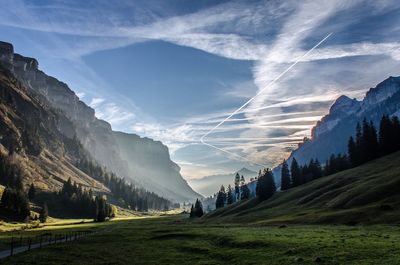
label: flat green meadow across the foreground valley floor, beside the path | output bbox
[2,215,400,265]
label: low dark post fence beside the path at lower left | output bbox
[0,230,94,259]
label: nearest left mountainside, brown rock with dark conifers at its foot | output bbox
[0,43,171,220]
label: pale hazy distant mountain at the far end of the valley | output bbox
[189,168,258,196]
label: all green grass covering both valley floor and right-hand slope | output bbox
[0,153,400,265]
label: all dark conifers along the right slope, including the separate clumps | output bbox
[206,115,400,208]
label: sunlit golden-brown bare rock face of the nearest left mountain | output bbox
[0,52,109,192]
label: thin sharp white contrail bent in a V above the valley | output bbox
[200,32,333,167]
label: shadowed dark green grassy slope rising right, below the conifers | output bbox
[203,152,400,224]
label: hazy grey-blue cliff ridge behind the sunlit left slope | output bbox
[0,42,201,201]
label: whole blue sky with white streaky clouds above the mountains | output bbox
[0,0,400,179]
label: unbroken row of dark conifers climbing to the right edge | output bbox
[281,115,400,190]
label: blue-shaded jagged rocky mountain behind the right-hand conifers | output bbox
[273,77,400,184]
